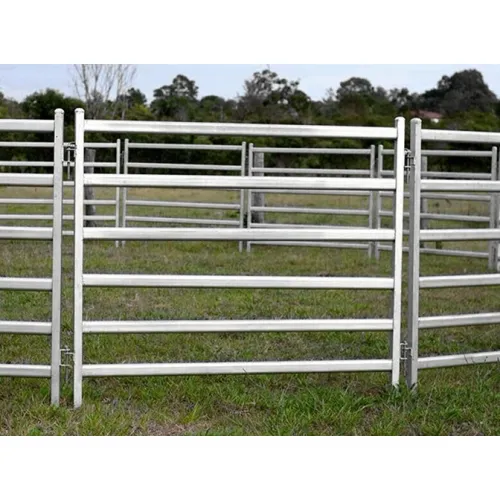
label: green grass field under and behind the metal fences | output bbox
[0,183,500,435]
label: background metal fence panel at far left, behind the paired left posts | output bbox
[0,139,121,238]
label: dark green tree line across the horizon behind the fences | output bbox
[0,65,500,174]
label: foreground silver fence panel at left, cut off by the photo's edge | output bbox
[0,109,64,405]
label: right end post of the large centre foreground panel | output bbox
[391,118,405,387]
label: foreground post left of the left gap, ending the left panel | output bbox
[50,109,64,406]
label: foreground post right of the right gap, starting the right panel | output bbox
[405,118,422,389]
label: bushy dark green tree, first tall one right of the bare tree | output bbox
[151,75,198,121]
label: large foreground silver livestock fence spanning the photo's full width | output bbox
[0,110,500,407]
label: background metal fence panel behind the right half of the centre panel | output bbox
[247,144,378,257]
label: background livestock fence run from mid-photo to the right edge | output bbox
[243,144,500,269]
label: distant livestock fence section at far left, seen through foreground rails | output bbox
[0,137,121,236]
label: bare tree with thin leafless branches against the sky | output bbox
[72,64,136,119]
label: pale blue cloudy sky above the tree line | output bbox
[0,64,500,100]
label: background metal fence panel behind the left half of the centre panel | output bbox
[121,139,246,252]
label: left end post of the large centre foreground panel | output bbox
[73,109,85,408]
